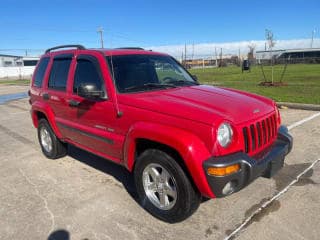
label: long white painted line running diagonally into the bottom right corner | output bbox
[224,159,320,240]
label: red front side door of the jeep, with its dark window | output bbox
[62,53,124,162]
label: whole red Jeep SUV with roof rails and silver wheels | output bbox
[30,45,292,223]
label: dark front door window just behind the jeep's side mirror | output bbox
[73,59,103,94]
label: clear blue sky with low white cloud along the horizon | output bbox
[0,0,320,56]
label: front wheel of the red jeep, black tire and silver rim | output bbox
[134,149,201,223]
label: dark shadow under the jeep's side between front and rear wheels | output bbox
[68,145,138,202]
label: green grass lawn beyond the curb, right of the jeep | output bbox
[190,64,320,104]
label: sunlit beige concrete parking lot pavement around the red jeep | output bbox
[0,86,320,240]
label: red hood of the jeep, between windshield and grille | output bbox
[119,85,274,124]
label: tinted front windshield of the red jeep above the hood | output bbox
[107,55,198,93]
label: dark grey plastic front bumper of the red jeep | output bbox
[203,126,293,197]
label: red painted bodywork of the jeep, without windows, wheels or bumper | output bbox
[30,47,280,198]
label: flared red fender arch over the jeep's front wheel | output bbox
[124,122,214,198]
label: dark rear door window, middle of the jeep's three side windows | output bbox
[48,58,72,91]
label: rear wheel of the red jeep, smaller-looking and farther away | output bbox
[38,119,67,159]
